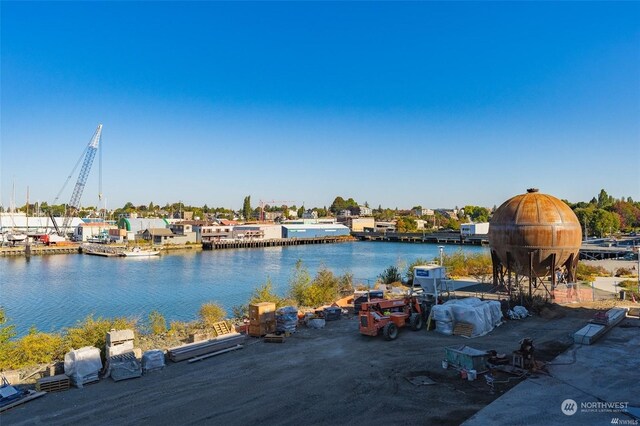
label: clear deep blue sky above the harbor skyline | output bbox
[0,1,640,209]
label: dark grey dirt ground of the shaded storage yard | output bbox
[0,307,594,426]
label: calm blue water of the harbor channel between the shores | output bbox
[0,242,487,334]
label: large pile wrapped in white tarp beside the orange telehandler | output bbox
[431,297,503,337]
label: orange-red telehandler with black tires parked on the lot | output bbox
[359,296,424,340]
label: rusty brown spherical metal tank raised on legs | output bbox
[489,189,582,277]
